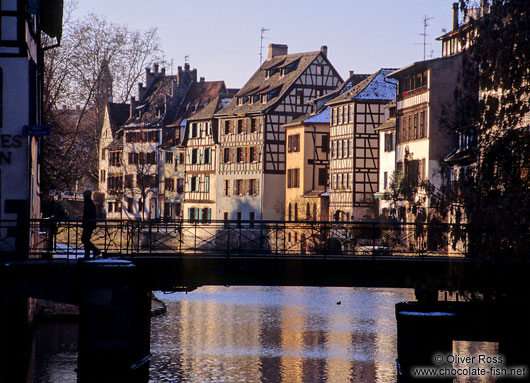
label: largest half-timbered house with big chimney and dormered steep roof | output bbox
[212,44,342,220]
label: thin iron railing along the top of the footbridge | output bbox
[0,218,478,259]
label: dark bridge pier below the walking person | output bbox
[78,260,151,383]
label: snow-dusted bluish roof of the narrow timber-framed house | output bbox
[327,69,397,105]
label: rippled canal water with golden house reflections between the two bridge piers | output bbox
[150,287,413,383]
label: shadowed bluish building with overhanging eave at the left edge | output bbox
[0,0,63,257]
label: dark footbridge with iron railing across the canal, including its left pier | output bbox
[0,219,530,382]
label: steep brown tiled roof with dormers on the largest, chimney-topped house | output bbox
[217,51,321,116]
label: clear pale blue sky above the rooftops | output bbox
[75,0,456,88]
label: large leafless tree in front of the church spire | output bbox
[42,2,161,195]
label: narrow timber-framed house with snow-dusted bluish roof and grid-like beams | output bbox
[327,69,396,220]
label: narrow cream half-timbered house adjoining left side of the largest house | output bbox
[159,77,228,221]
